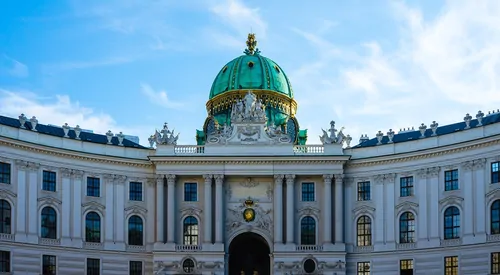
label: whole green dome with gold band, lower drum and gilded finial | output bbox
[206,34,297,128]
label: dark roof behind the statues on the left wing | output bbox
[0,116,147,149]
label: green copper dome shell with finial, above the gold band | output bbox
[209,34,293,99]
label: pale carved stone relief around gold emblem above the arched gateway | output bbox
[226,198,273,236]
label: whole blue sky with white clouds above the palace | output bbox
[0,0,500,146]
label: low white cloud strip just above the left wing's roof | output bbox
[0,89,154,145]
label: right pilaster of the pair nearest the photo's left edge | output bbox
[27,162,38,242]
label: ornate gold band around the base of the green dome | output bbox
[206,89,298,117]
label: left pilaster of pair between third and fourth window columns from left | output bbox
[101,174,114,244]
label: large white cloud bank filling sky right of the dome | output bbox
[290,0,500,146]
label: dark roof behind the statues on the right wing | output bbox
[352,112,500,148]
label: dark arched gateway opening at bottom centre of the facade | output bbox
[228,232,271,275]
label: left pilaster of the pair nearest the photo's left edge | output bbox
[16,160,28,241]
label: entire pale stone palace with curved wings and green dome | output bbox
[0,35,500,275]
